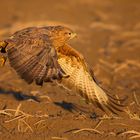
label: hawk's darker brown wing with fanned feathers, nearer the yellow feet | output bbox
[6,27,65,85]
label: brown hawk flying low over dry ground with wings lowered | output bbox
[0,26,123,114]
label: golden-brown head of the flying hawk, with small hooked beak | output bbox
[46,26,77,46]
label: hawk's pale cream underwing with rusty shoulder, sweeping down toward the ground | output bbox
[58,46,123,113]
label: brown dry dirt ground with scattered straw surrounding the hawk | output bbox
[0,0,140,140]
